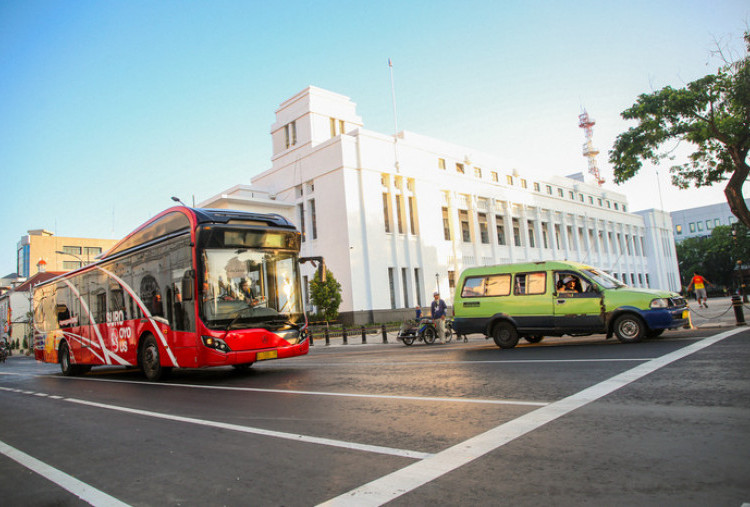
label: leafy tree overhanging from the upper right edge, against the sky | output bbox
[609,31,750,227]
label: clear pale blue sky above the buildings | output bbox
[0,0,750,276]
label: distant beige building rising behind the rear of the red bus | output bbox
[16,229,117,278]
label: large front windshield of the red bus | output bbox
[201,247,304,329]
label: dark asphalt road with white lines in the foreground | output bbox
[0,327,750,506]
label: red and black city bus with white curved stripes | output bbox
[34,206,309,380]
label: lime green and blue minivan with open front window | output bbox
[453,261,688,349]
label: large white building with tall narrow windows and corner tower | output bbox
[200,87,680,323]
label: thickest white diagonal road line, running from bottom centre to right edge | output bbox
[320,328,745,507]
